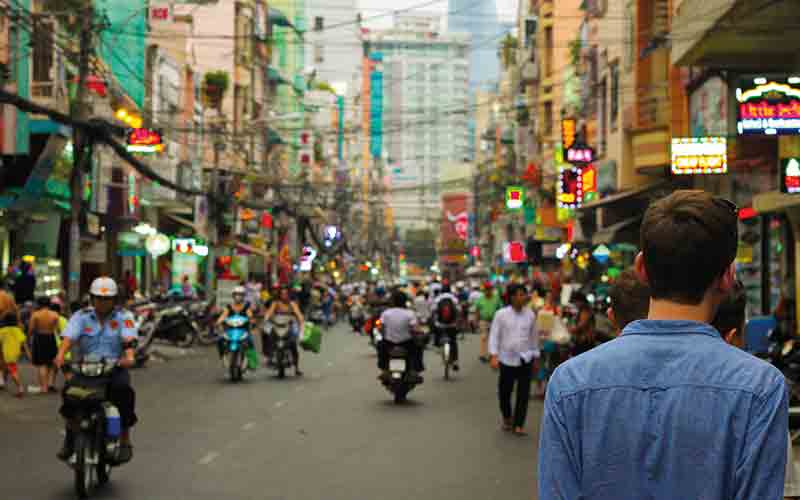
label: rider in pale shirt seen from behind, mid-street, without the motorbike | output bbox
[378,290,425,383]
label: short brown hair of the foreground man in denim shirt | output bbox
[640,190,739,305]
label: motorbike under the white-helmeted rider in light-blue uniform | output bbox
[64,356,122,498]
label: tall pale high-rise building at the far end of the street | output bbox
[362,16,471,234]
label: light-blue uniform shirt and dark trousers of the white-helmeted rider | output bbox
[61,307,138,428]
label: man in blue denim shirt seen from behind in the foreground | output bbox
[539,191,788,500]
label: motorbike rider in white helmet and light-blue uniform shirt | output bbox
[55,276,138,463]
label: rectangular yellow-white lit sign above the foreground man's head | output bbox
[672,137,728,175]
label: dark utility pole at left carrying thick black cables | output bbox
[68,4,94,301]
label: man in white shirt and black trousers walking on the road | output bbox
[489,284,539,436]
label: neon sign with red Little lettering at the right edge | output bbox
[736,76,800,135]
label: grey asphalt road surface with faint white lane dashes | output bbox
[0,325,541,500]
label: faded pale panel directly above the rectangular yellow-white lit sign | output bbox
[689,76,728,137]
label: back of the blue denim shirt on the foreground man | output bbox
[542,320,786,500]
